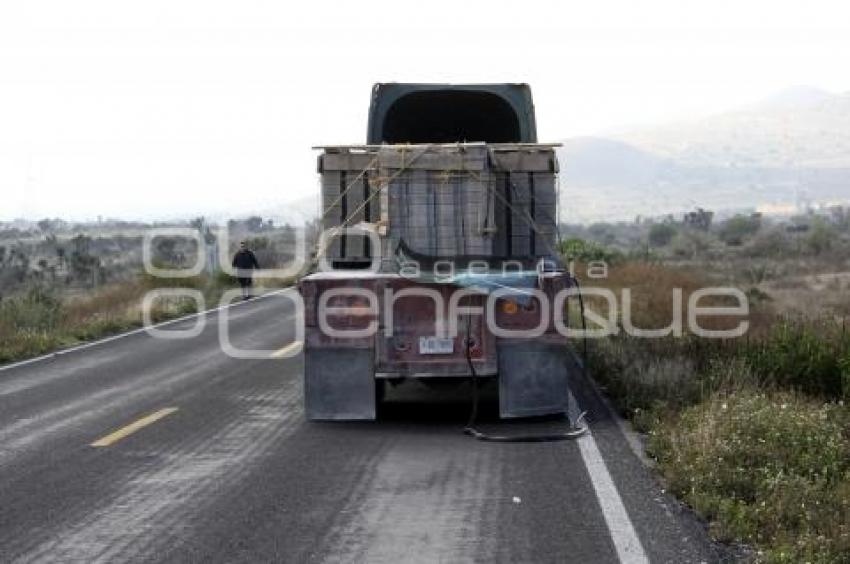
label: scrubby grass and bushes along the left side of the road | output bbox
[0,214,308,363]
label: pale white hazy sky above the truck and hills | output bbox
[0,0,850,220]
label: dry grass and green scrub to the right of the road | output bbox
[565,205,850,563]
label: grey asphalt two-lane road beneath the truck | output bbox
[0,296,722,563]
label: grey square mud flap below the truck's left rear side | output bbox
[304,347,375,421]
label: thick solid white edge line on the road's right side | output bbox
[577,430,649,564]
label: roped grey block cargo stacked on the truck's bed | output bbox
[318,143,558,264]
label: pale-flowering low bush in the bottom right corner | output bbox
[649,390,850,562]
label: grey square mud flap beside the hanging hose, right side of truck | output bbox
[498,340,574,418]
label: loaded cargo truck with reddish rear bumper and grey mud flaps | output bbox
[299,83,572,420]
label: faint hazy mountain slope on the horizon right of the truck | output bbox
[559,87,850,221]
